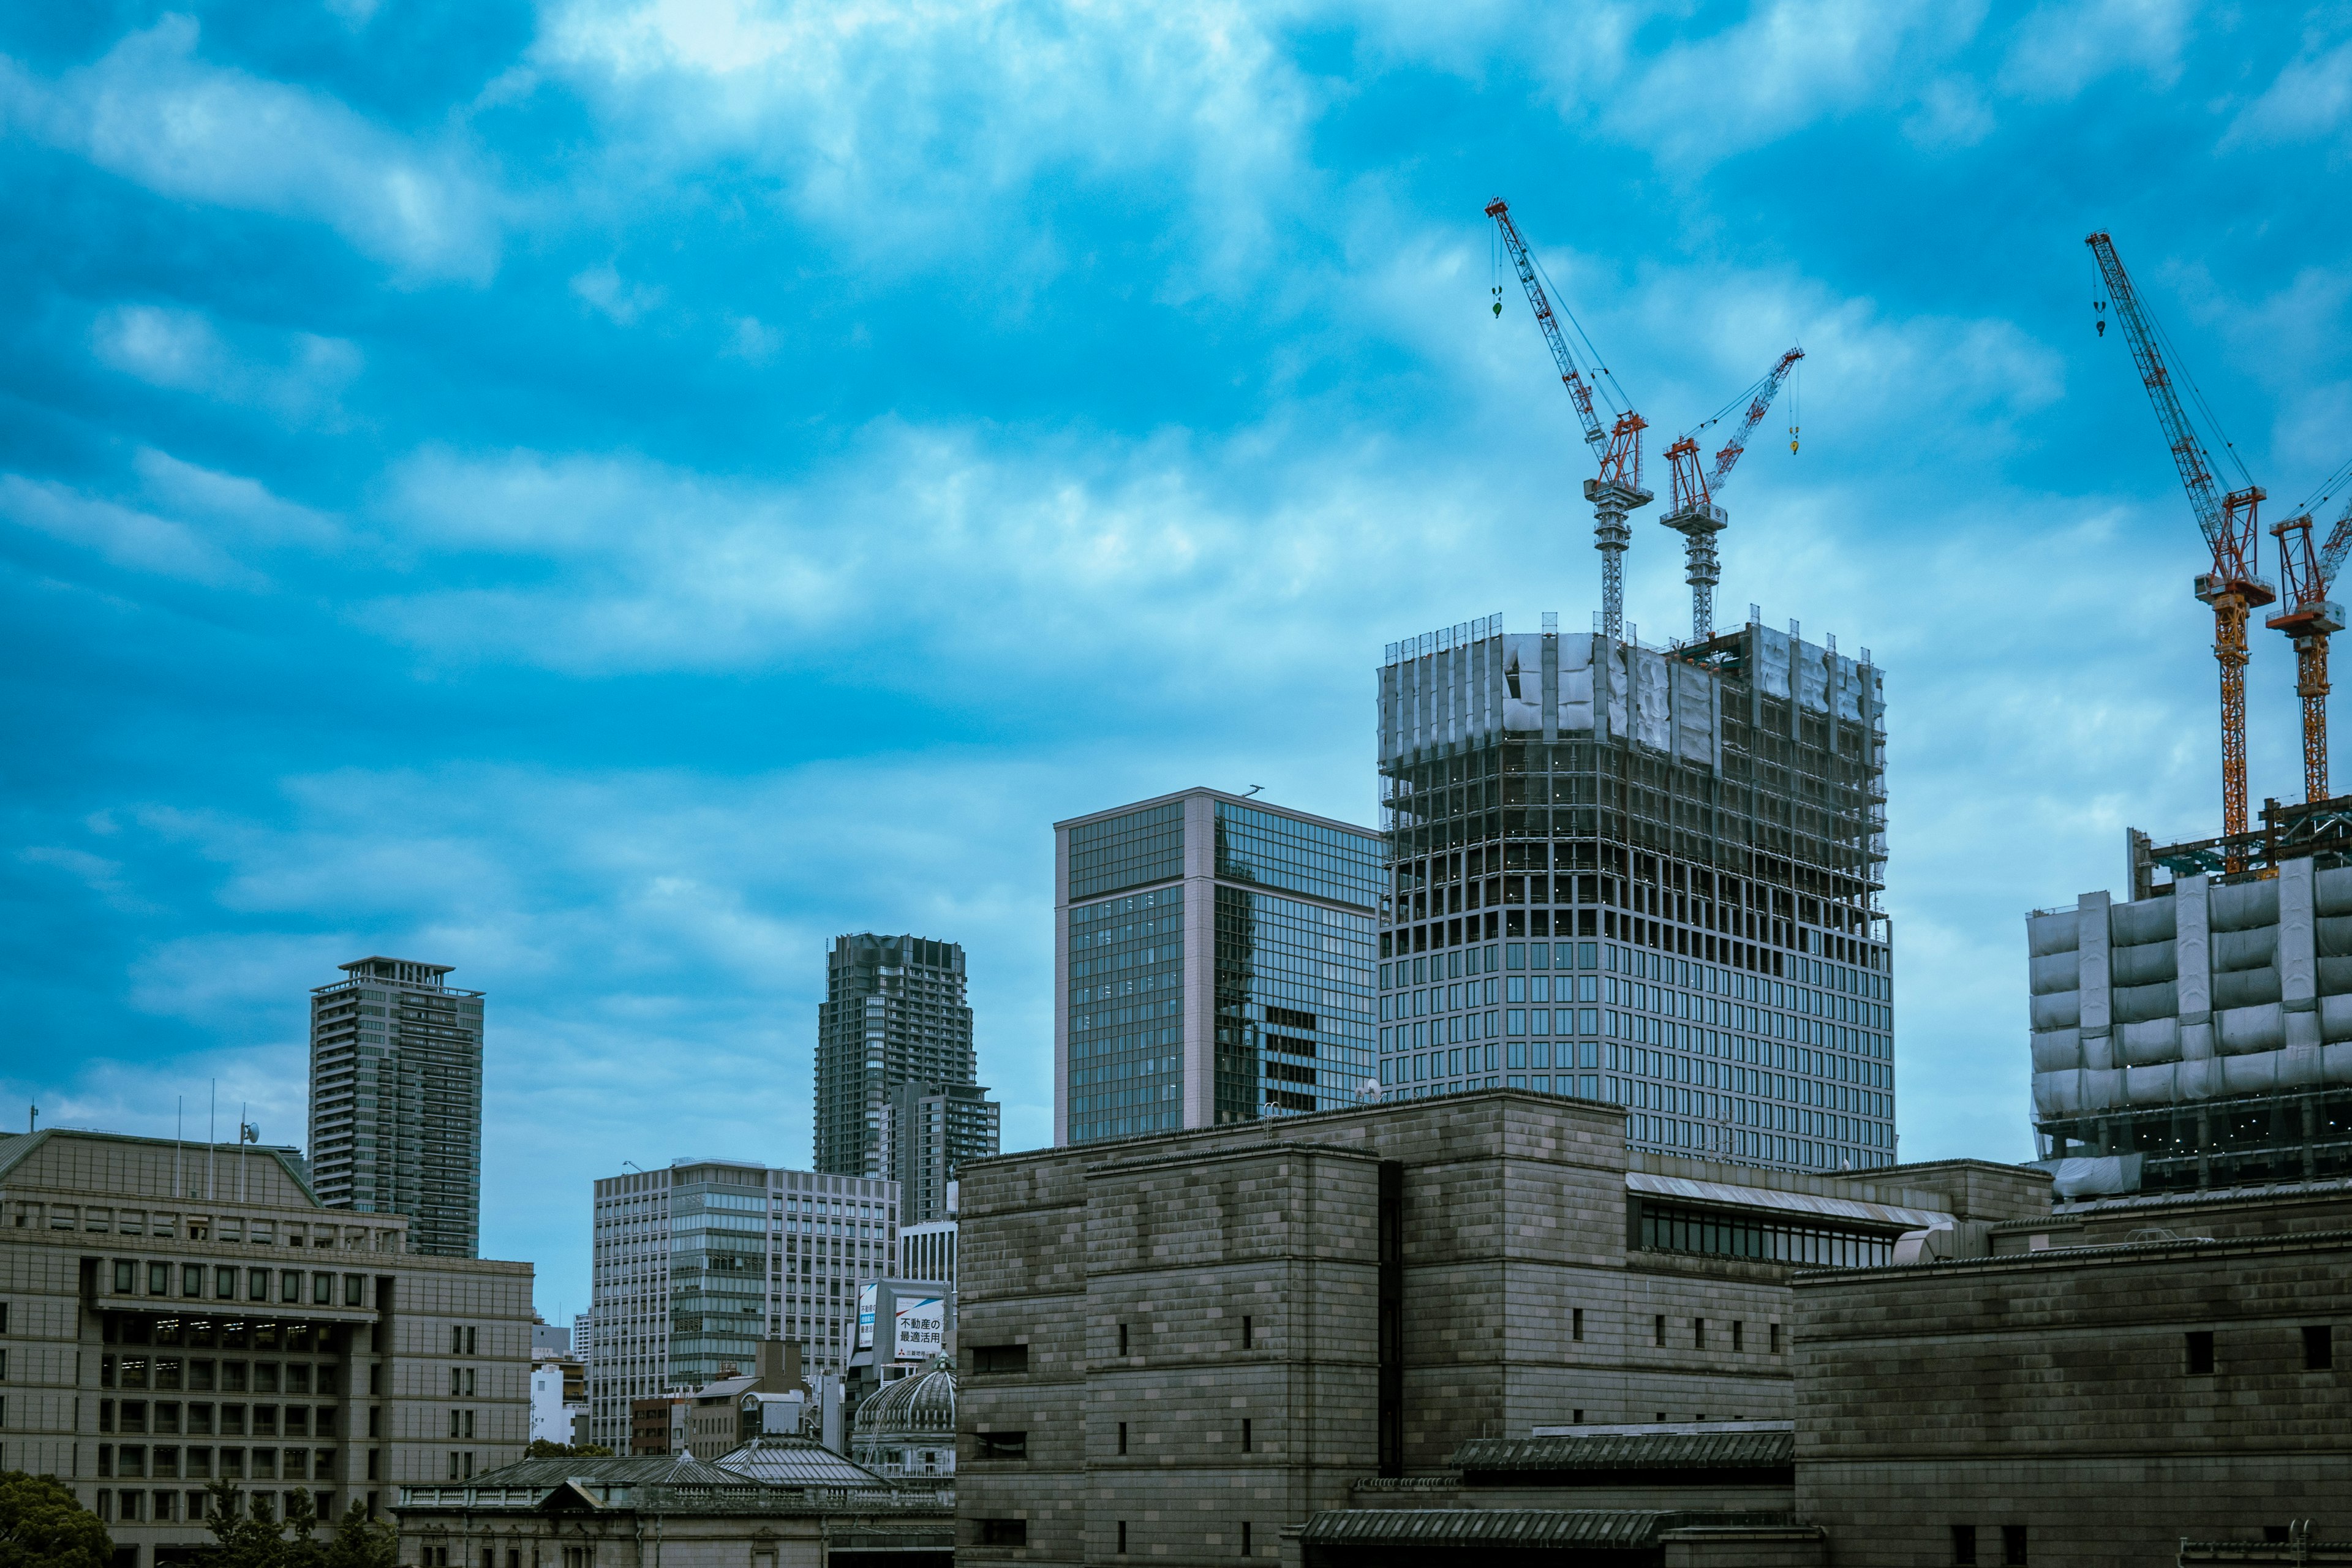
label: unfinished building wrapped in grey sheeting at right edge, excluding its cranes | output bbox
[2025,797,2352,1192]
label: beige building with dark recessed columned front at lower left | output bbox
[0,1128,532,1568]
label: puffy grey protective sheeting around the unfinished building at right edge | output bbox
[2025,861,2352,1121]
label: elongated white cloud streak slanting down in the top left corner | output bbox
[0,14,499,282]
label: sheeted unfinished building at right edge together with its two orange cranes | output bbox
[2027,233,2352,1197]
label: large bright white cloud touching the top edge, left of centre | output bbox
[534,0,1310,278]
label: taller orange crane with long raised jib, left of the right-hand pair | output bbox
[2084,230,2279,846]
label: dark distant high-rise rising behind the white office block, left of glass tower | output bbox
[816,931,978,1178]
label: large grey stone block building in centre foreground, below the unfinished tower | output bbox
[957,1088,2049,1563]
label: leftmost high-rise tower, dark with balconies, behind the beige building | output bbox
[311,957,482,1257]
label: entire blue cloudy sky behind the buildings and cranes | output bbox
[0,0,2352,1316]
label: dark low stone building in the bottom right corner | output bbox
[1792,1180,2352,1568]
